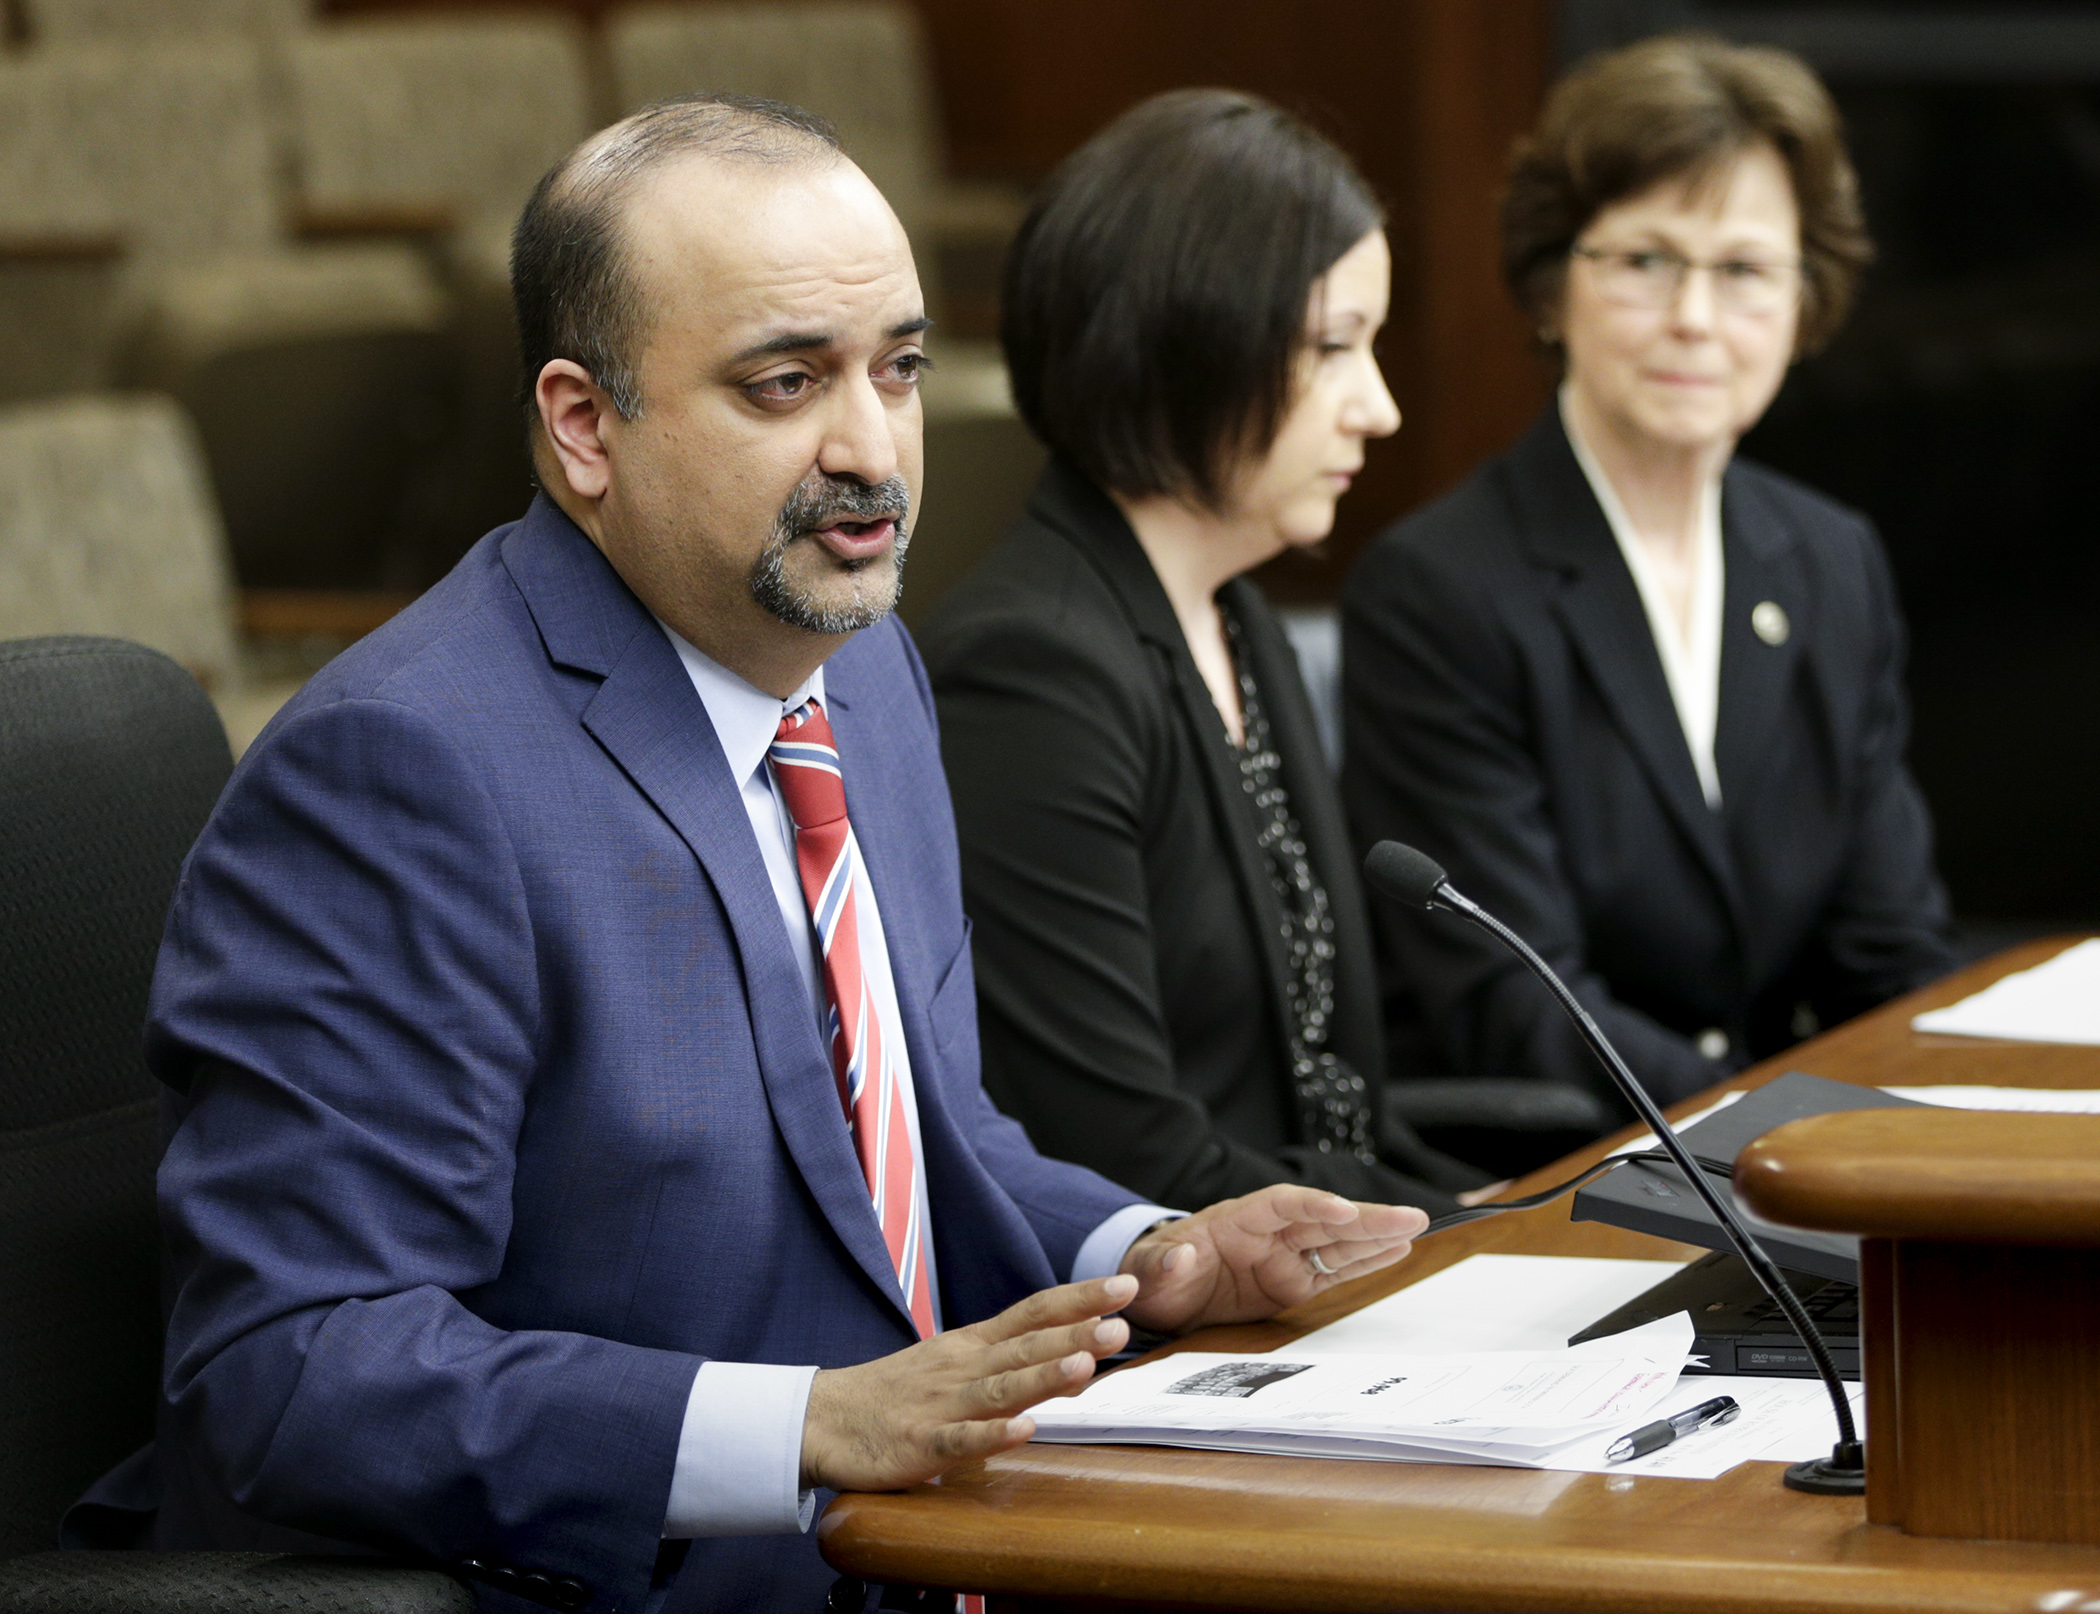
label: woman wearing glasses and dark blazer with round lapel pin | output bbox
[1342,36,1949,1102]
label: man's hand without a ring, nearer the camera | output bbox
[802,1276,1134,1490]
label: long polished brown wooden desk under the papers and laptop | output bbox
[819,938,2100,1614]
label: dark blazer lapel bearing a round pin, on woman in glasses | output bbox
[1714,474,1814,812]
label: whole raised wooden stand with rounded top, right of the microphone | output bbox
[1735,1057,2100,1545]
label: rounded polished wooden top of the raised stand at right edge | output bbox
[1735,1110,2100,1245]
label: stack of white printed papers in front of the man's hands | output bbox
[1033,1314,1693,1467]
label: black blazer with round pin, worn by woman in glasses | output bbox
[1342,409,1949,1100]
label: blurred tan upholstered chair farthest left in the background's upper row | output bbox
[0,37,458,590]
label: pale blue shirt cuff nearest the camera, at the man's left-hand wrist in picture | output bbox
[664,1360,818,1541]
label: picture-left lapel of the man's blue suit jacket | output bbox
[504,500,911,1329]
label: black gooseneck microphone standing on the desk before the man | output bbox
[1363,842,1867,1496]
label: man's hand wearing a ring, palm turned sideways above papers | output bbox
[1124,1184,1430,1333]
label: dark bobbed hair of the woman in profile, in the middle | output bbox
[1000,90,1386,510]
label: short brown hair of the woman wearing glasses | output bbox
[1502,34,1873,353]
